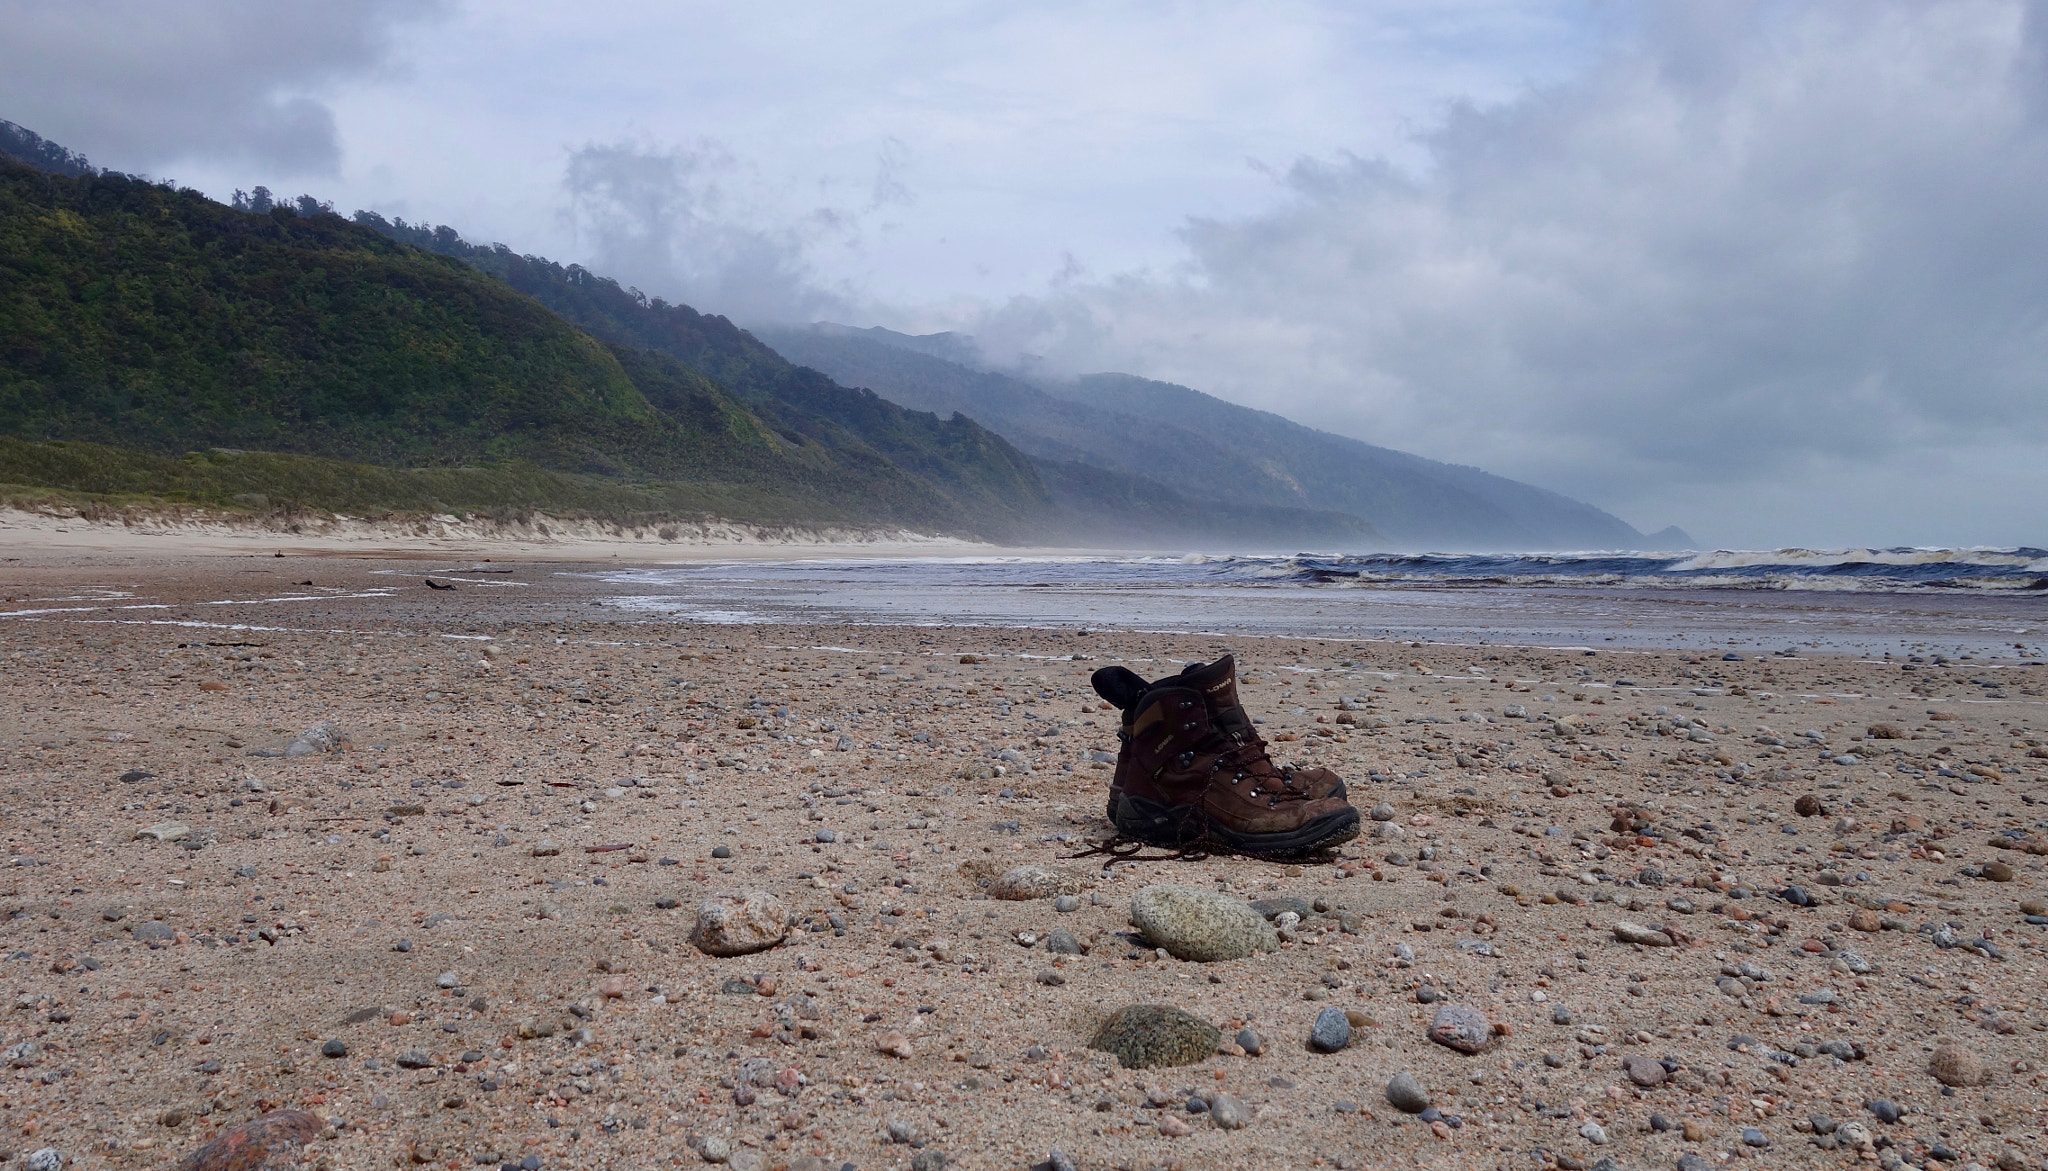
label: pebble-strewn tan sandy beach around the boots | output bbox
[0,524,2048,1171]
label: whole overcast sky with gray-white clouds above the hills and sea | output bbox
[0,0,2048,547]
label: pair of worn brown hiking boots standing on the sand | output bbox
[1090,655,1358,858]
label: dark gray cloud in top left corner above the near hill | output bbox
[0,0,442,174]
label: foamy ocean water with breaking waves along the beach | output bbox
[596,549,2048,659]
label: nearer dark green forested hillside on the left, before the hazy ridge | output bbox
[0,162,1051,538]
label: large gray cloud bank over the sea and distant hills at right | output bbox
[946,0,2048,540]
